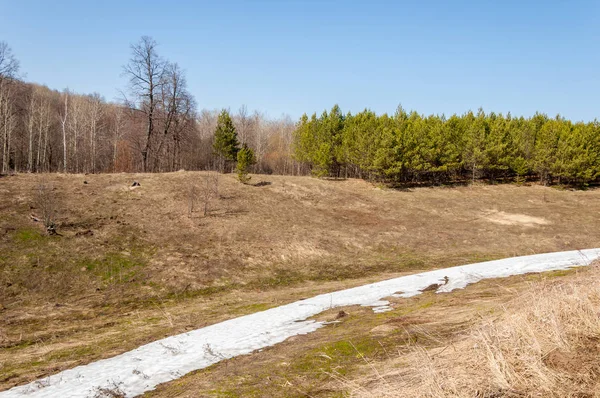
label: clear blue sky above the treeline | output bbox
[0,0,600,121]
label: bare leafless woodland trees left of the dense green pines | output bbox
[0,37,304,174]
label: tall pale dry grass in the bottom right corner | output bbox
[350,266,600,398]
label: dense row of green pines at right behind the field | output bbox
[293,105,600,185]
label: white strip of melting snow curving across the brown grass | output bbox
[0,249,600,398]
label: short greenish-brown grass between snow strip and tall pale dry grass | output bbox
[146,271,586,398]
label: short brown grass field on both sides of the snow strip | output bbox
[0,172,600,397]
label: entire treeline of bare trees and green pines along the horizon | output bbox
[0,37,600,185]
